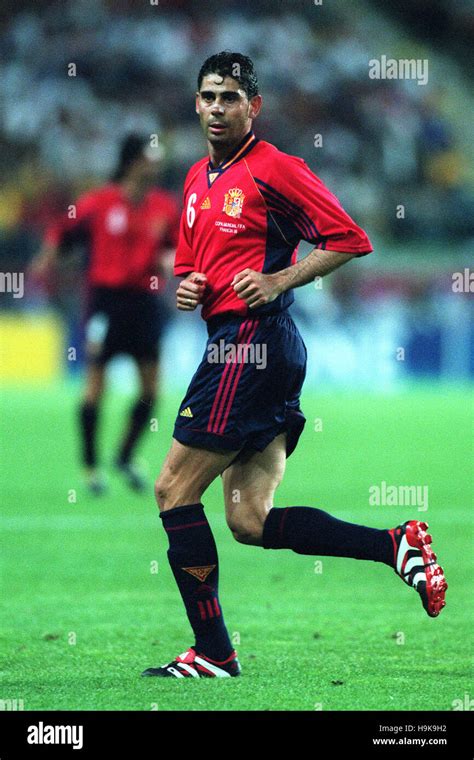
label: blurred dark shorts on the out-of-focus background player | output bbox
[85,287,166,364]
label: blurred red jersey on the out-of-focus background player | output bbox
[45,184,179,290]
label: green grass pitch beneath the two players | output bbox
[0,385,473,711]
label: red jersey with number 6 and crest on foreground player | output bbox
[174,132,373,319]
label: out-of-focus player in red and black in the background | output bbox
[32,134,179,495]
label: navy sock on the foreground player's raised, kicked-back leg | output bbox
[262,507,393,565]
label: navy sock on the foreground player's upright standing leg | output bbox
[160,504,233,661]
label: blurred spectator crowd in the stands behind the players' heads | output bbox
[0,0,474,276]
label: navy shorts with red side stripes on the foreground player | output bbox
[174,312,306,456]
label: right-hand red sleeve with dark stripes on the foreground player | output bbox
[266,156,373,256]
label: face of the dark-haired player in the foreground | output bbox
[196,74,262,148]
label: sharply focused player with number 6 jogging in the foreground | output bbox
[142,52,447,678]
